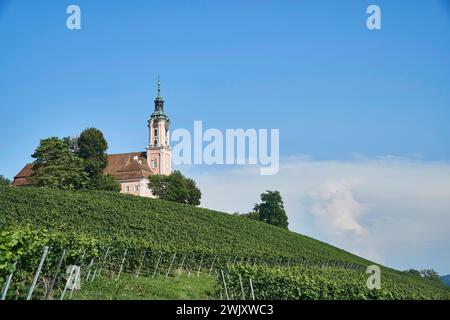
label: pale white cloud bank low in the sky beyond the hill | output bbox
[187,156,450,273]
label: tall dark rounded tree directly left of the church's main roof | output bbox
[77,128,108,180]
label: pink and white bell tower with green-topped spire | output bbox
[147,76,172,175]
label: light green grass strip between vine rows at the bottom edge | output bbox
[72,274,215,300]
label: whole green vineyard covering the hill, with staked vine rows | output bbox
[0,187,450,299]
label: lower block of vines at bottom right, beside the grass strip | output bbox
[222,264,450,300]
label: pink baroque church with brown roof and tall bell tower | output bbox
[13,79,172,198]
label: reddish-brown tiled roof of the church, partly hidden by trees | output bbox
[13,152,152,187]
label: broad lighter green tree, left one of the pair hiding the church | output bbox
[32,137,89,189]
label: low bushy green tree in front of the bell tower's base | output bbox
[148,171,202,206]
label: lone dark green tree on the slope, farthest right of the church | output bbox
[253,190,288,229]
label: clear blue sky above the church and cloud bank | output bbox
[0,0,450,272]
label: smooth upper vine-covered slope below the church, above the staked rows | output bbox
[0,188,448,298]
